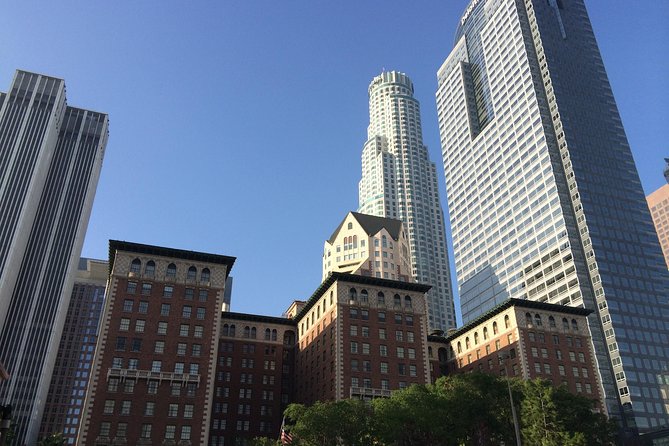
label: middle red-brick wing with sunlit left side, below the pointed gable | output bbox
[291,272,430,404]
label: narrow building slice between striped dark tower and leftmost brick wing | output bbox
[40,258,109,444]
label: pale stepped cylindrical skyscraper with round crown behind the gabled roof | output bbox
[358,71,455,330]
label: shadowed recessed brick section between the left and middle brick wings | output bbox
[209,312,296,446]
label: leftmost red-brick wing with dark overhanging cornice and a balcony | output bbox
[78,241,235,446]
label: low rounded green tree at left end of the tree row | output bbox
[284,399,371,446]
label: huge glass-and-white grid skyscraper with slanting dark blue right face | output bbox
[437,0,669,431]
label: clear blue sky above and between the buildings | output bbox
[0,0,669,315]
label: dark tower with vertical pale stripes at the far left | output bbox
[0,71,108,444]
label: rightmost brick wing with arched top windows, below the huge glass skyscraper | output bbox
[428,299,604,411]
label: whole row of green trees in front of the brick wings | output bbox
[282,373,616,446]
